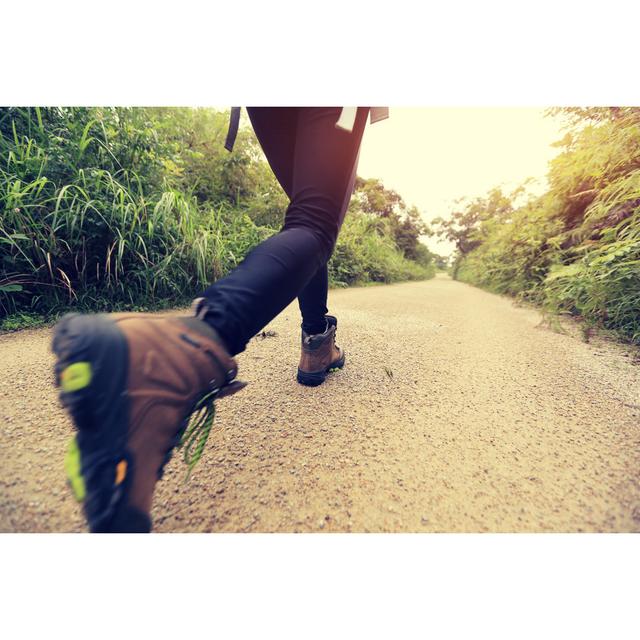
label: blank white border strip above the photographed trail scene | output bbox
[5,0,640,106]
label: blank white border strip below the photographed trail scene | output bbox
[0,534,640,640]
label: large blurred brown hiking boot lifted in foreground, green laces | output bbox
[52,302,244,533]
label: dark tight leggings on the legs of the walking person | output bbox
[202,107,368,355]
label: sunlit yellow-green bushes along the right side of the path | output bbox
[434,107,640,344]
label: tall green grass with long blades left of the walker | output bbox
[0,110,271,322]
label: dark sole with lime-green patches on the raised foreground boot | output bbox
[52,314,150,532]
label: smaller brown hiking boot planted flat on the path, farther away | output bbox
[298,316,344,387]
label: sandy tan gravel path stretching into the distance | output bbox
[0,276,640,532]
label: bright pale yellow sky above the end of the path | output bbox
[358,107,564,255]
